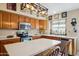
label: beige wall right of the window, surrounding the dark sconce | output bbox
[66,9,79,51]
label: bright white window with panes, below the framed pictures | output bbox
[52,19,66,35]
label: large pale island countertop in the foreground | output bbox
[4,38,61,56]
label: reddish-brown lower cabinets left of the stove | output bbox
[0,38,20,56]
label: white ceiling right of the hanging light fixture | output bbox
[41,3,79,15]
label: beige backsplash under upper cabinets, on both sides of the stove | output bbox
[0,29,39,37]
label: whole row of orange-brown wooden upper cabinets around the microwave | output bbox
[0,11,47,30]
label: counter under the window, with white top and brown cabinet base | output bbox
[32,34,77,55]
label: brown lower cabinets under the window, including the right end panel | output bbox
[32,36,74,55]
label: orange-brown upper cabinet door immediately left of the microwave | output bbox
[11,13,19,29]
